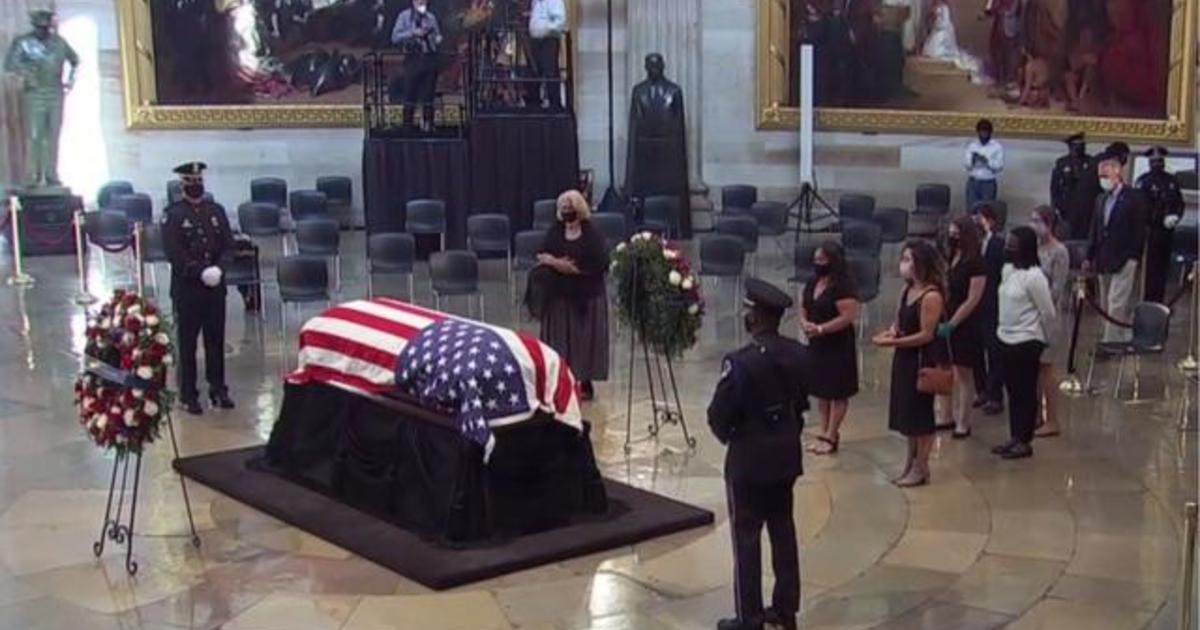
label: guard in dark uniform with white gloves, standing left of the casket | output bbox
[162,162,233,414]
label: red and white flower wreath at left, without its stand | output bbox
[74,290,173,454]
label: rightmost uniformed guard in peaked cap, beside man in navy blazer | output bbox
[1136,146,1183,302]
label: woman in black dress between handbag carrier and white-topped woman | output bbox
[937,216,988,439]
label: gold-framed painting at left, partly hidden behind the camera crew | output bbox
[116,0,571,128]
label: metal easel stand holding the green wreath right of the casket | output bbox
[624,262,696,456]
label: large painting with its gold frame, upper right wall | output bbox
[757,0,1198,143]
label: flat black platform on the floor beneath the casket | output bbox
[175,446,713,590]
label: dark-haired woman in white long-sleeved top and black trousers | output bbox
[991,226,1057,460]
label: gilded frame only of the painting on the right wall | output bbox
[756,0,1198,143]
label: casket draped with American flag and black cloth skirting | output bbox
[264,299,606,542]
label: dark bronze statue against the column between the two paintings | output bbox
[625,53,691,238]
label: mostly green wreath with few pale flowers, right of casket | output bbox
[610,232,704,358]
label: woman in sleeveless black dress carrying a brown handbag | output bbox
[871,240,944,487]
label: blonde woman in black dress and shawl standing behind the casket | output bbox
[538,190,608,401]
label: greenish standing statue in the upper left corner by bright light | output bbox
[4,8,79,188]
